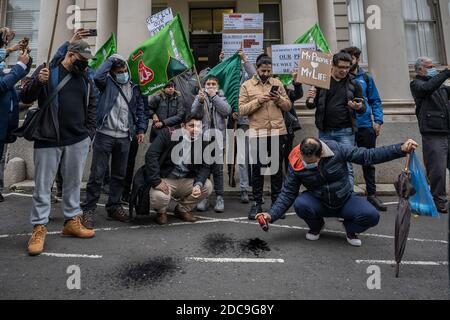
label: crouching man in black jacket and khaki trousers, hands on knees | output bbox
[145,115,212,225]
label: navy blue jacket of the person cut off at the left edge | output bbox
[0,65,27,142]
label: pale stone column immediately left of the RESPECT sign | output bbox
[117,0,152,57]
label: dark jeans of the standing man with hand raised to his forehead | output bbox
[83,133,130,211]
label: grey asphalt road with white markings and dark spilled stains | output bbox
[0,195,449,300]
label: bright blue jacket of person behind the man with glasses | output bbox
[354,69,384,128]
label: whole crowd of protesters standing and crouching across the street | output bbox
[0,28,450,256]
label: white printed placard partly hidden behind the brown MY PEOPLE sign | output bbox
[271,44,316,74]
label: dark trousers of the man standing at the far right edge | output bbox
[422,135,450,205]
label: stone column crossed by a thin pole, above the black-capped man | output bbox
[37,0,75,64]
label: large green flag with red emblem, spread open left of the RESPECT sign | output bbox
[128,15,194,96]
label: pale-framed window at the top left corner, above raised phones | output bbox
[6,0,40,65]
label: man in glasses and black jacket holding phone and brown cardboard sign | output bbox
[306,52,366,187]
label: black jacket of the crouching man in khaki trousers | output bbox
[144,128,211,188]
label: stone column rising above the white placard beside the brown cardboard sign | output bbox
[281,0,319,44]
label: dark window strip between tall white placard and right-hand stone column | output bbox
[259,3,282,49]
